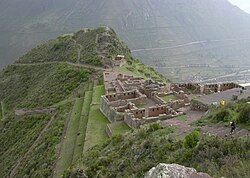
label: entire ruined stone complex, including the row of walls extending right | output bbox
[100,69,248,128]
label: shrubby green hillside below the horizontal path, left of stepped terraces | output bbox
[0,60,92,177]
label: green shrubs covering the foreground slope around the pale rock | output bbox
[66,124,250,177]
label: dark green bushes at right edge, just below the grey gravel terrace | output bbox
[197,100,250,130]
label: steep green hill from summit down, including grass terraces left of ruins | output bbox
[0,27,164,177]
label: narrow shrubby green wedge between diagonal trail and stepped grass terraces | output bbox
[12,104,71,177]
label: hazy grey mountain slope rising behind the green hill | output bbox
[0,0,250,80]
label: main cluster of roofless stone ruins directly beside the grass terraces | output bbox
[100,70,189,128]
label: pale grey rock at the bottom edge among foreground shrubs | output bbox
[145,163,211,178]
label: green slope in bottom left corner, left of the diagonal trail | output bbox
[0,116,50,177]
